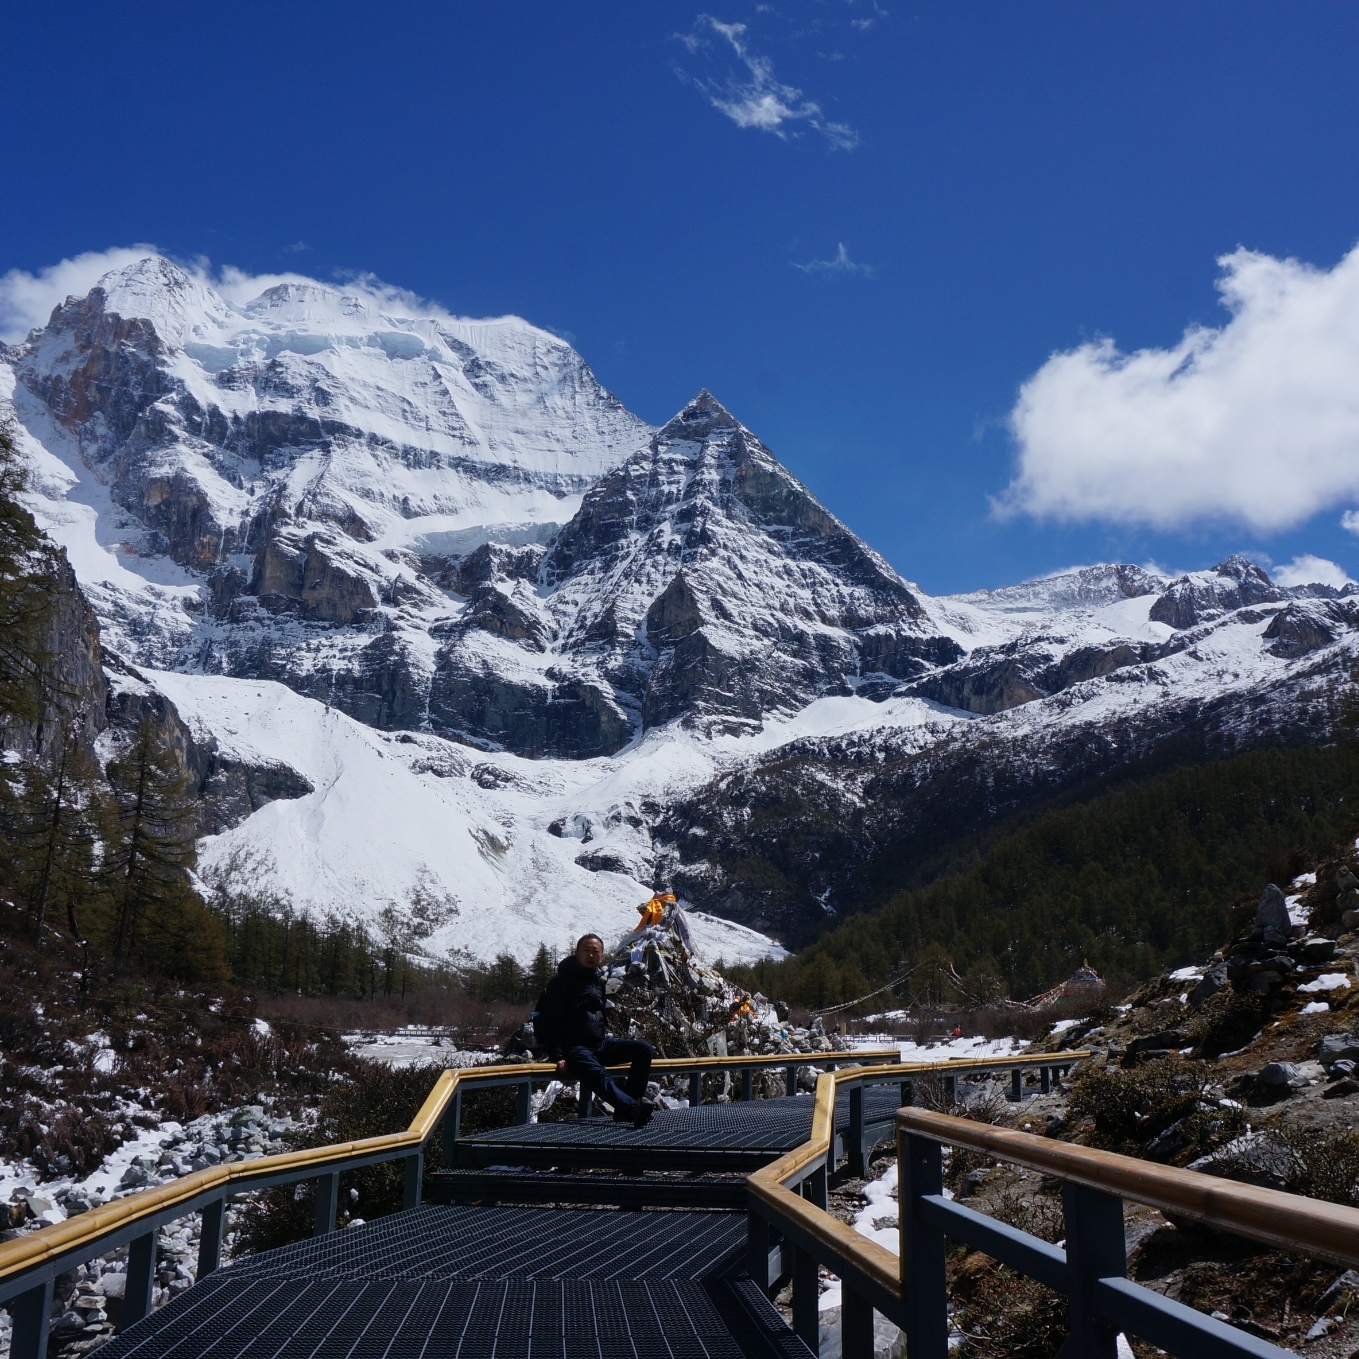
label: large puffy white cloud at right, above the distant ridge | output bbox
[996,247,1359,531]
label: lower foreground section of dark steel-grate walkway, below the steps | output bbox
[102,1205,810,1359]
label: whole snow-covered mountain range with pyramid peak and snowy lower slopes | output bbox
[0,255,1359,959]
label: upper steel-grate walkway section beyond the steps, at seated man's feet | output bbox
[453,1084,901,1171]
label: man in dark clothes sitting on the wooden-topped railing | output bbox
[535,935,654,1128]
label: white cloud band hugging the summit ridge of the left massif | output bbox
[0,246,478,342]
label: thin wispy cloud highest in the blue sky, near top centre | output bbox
[675,14,859,151]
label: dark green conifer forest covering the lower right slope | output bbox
[731,742,1359,1008]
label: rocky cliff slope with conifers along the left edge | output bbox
[0,428,475,998]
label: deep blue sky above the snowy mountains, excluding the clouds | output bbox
[0,0,1359,593]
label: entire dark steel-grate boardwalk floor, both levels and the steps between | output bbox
[90,1086,900,1359]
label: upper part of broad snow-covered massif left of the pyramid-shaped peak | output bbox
[4,257,651,660]
